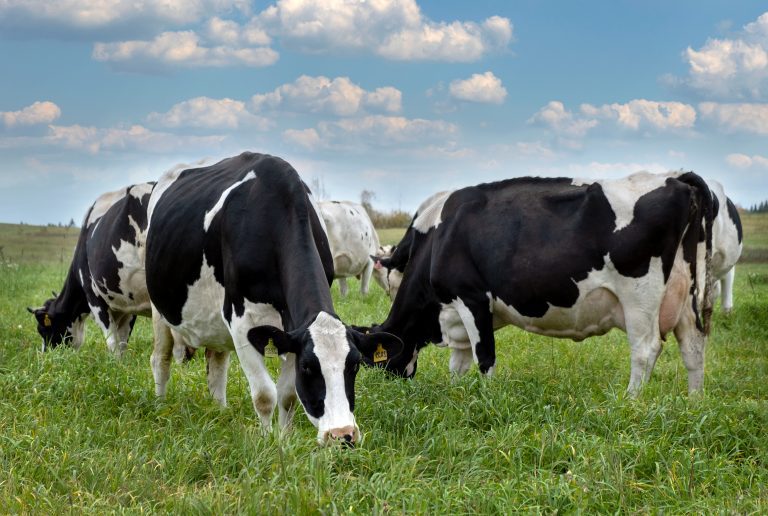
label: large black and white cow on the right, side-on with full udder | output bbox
[360,173,712,394]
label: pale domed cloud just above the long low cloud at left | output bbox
[147,97,271,130]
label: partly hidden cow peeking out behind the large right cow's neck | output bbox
[371,190,453,301]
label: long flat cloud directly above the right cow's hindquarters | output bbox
[581,99,696,130]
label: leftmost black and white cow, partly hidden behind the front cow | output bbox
[28,183,154,357]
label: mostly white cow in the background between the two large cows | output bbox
[318,201,379,296]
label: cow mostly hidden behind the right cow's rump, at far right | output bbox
[707,180,743,314]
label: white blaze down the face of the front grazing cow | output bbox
[309,312,360,443]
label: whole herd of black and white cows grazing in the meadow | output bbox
[29,152,742,444]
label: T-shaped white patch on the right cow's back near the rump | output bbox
[571,170,668,231]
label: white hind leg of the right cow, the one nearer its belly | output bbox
[625,305,661,398]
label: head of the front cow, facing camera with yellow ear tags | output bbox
[248,312,403,444]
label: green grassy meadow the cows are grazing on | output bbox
[0,215,768,514]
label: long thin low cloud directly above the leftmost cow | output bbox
[45,125,224,154]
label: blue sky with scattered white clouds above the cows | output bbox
[0,0,768,224]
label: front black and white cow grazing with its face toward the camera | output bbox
[146,153,402,442]
